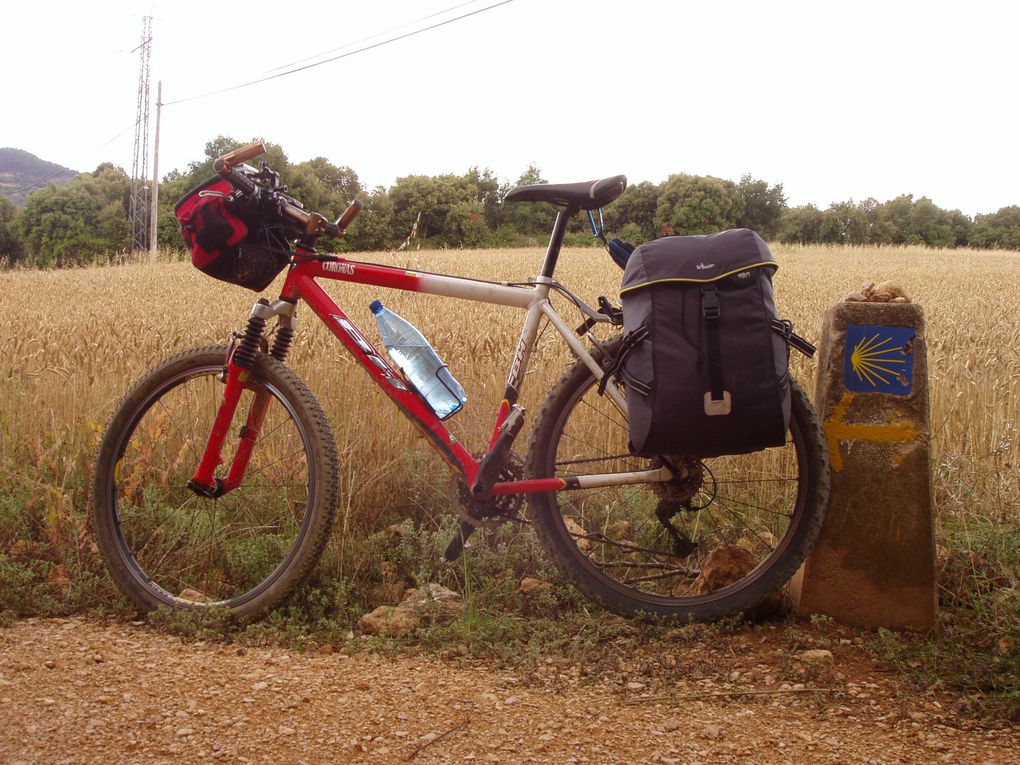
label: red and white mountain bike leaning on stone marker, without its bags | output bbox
[93,144,828,622]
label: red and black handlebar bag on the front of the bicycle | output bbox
[173,176,291,292]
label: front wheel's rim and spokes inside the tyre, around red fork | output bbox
[109,362,315,609]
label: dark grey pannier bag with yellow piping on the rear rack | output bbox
[607,228,814,457]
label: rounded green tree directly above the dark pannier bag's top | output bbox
[655,173,744,236]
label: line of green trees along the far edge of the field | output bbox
[0,137,1020,267]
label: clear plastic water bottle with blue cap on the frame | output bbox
[369,300,467,419]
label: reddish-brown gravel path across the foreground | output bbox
[0,618,1020,765]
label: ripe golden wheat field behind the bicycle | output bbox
[0,246,1020,544]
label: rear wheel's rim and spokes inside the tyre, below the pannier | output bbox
[544,371,808,610]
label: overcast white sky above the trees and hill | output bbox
[0,0,1020,214]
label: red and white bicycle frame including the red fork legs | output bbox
[190,232,672,499]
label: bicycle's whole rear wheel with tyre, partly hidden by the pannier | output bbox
[527,341,828,622]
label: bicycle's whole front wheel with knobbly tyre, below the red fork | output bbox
[92,346,339,618]
